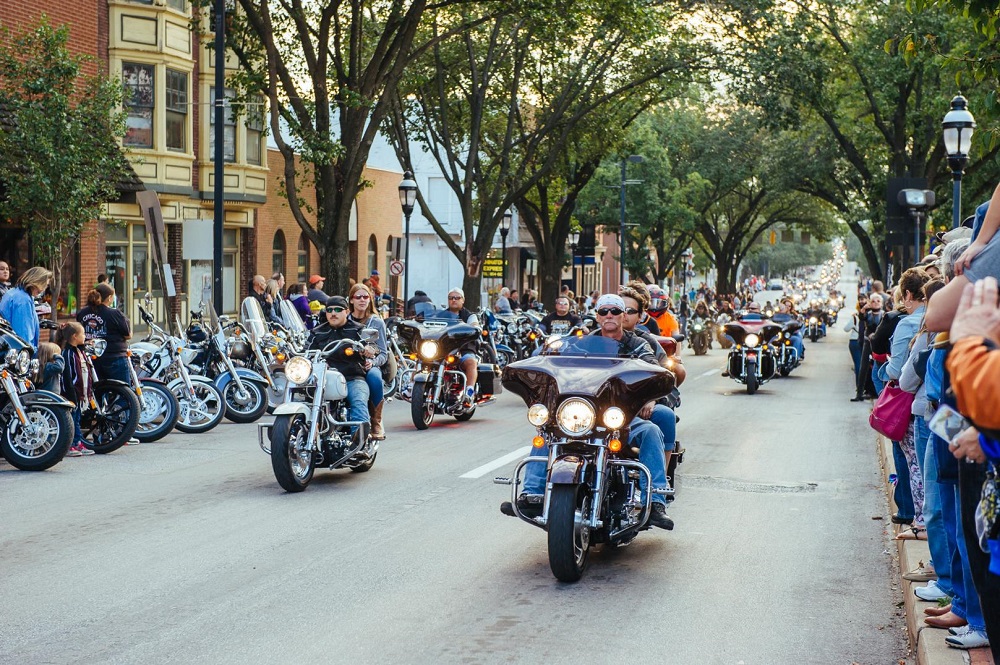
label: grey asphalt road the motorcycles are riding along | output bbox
[0,272,906,665]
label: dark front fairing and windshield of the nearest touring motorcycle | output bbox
[503,335,674,420]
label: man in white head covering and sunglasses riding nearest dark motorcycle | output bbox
[508,293,674,530]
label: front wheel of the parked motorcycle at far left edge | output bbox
[0,403,74,471]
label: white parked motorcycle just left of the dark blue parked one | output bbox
[132,298,226,434]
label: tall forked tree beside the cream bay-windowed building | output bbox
[196,0,484,293]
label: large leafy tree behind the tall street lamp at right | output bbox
[730,0,997,274]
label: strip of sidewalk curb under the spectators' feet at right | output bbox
[878,436,994,665]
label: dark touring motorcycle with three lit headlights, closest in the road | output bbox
[494,335,674,582]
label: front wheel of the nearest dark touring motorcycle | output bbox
[547,485,590,582]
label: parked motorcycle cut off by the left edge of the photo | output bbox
[0,318,74,471]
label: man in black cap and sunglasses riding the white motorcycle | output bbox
[309,296,372,430]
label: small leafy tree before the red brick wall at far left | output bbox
[0,16,129,319]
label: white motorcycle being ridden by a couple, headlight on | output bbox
[257,330,378,492]
